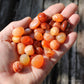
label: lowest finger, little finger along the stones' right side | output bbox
[51,32,77,64]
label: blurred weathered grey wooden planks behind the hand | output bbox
[0,0,84,84]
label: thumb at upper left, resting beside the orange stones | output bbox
[0,17,32,41]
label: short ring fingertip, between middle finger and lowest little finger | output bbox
[68,14,80,31]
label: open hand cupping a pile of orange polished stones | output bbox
[0,3,80,84]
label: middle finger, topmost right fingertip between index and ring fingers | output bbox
[61,3,77,18]
